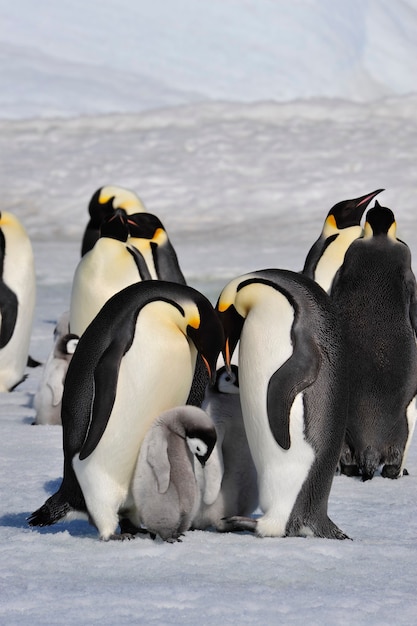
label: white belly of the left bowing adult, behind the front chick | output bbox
[73,306,196,539]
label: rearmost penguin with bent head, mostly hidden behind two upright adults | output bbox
[81,185,146,256]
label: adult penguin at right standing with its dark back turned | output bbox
[332,202,417,480]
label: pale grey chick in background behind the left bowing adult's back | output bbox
[33,311,78,424]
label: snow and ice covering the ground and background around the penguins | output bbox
[0,0,417,626]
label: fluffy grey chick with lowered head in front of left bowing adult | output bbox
[132,406,216,542]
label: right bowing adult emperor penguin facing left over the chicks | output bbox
[217,269,348,539]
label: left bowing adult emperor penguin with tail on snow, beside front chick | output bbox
[28,280,223,540]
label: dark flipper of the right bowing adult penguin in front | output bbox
[267,333,321,450]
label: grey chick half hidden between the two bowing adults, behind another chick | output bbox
[192,365,258,532]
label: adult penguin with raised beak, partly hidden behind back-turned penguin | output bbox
[303,189,384,293]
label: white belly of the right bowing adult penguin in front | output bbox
[239,292,314,536]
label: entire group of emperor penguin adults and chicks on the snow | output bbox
[0,186,417,542]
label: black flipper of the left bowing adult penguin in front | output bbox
[79,343,123,461]
